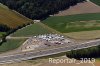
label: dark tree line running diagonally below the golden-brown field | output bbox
[0,22,33,45]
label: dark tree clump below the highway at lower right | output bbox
[66,46,100,59]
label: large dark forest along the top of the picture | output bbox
[0,0,85,19]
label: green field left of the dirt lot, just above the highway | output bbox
[0,39,25,53]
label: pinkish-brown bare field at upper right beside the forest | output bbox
[55,2,100,16]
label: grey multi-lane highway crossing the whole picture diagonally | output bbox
[0,39,100,64]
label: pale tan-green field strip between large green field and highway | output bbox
[64,30,100,40]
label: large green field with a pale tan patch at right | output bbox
[43,13,100,33]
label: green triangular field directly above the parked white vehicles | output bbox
[12,23,51,37]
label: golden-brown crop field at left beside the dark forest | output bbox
[0,4,32,28]
